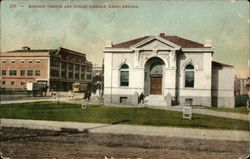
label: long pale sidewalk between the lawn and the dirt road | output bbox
[1,119,250,141]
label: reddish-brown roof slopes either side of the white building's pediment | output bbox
[112,35,209,48]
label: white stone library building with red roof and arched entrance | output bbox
[103,33,234,107]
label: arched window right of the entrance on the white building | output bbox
[185,64,194,88]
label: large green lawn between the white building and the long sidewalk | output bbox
[0,102,249,131]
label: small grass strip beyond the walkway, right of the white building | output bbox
[192,106,249,114]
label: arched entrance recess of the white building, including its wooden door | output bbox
[144,57,164,95]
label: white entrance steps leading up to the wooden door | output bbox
[145,95,167,106]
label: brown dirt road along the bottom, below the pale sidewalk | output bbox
[0,128,249,159]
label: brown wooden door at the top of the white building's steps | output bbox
[150,77,162,94]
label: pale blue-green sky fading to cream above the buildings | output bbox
[0,0,250,77]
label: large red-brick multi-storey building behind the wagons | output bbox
[0,47,92,91]
